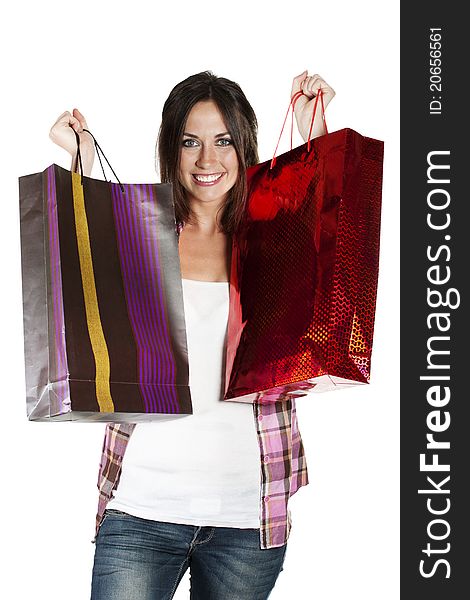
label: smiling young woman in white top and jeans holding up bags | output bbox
[50,71,335,600]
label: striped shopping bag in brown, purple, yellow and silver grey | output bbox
[19,132,192,422]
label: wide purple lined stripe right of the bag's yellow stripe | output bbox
[111,184,179,413]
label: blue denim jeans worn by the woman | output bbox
[91,510,287,600]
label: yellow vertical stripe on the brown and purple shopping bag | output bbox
[72,173,114,412]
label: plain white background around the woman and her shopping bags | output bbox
[0,0,399,600]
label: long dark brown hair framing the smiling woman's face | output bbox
[157,71,259,234]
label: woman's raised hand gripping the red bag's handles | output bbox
[291,71,336,141]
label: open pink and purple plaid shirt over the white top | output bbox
[93,223,308,549]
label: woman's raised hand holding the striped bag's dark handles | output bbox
[49,108,95,176]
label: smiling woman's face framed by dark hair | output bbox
[179,100,238,207]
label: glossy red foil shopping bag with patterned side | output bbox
[224,129,384,402]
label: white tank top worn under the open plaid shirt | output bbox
[107,279,261,528]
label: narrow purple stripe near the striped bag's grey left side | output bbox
[47,165,70,413]
